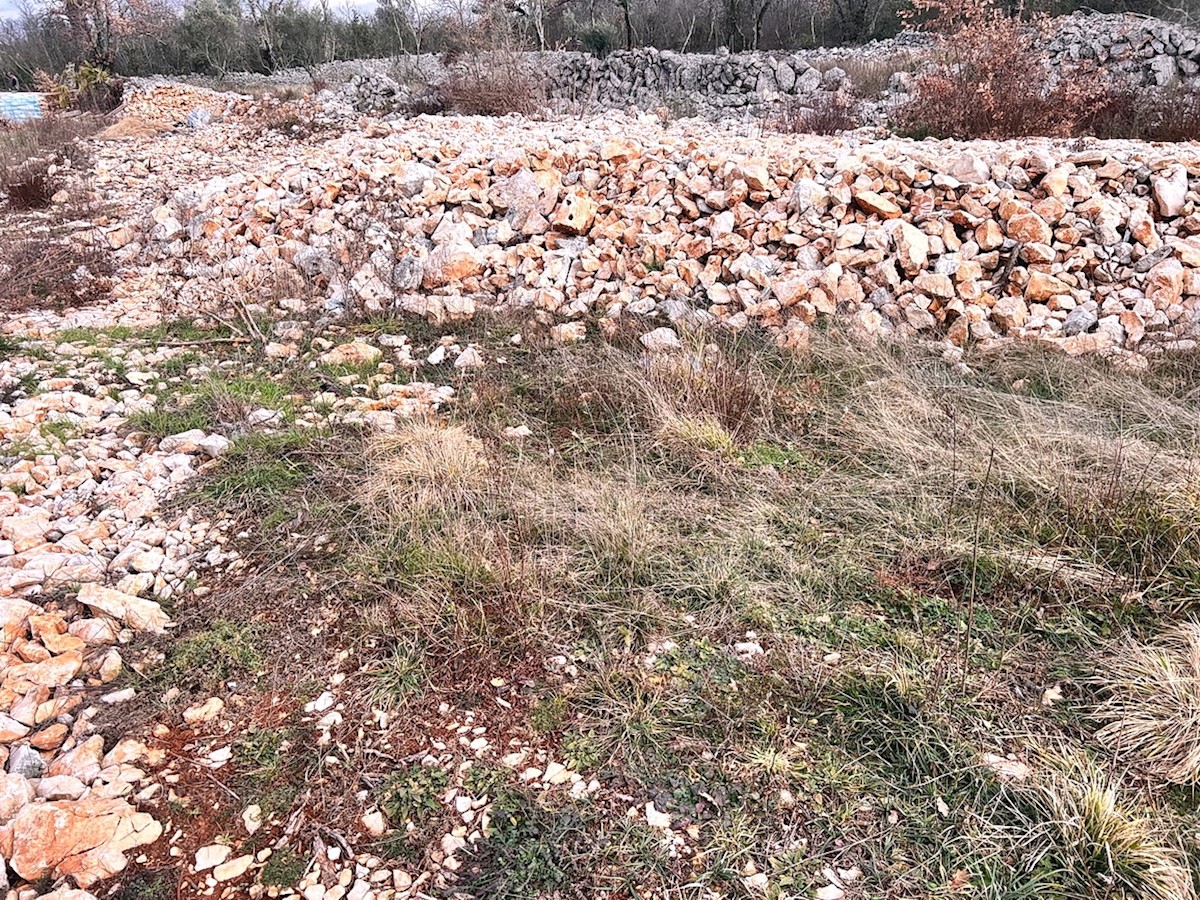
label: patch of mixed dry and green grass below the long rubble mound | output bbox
[172,323,1200,900]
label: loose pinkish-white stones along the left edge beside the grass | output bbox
[0,367,220,896]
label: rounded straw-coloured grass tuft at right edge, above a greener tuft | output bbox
[1096,622,1200,784]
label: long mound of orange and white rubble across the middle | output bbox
[108,103,1200,362]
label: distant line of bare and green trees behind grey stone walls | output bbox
[0,0,1196,85]
